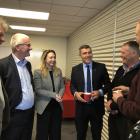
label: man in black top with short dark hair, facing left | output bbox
[106,41,140,140]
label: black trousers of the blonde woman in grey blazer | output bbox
[36,99,62,140]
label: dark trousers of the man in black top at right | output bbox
[108,113,129,140]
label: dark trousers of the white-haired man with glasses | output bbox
[1,108,34,140]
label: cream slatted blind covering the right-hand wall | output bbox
[66,0,140,140]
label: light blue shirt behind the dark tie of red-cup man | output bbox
[83,62,93,92]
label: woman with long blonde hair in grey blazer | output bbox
[34,50,64,140]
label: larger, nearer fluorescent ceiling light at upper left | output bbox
[0,8,49,20]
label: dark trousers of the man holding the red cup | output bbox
[75,103,103,140]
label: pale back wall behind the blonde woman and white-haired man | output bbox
[0,34,67,76]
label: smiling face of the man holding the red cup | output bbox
[80,48,93,64]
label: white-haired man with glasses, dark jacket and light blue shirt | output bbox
[0,33,34,140]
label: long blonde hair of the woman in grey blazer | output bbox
[40,50,61,77]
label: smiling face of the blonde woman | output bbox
[45,52,56,69]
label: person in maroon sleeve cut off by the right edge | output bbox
[113,21,140,140]
